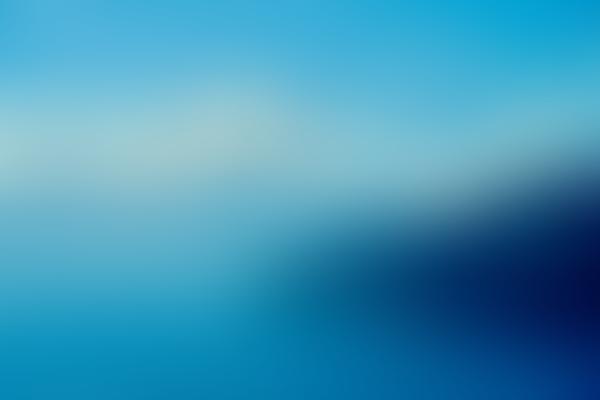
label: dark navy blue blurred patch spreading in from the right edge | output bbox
[276,168,600,399]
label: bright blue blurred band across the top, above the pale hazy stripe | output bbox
[0,0,599,113]
